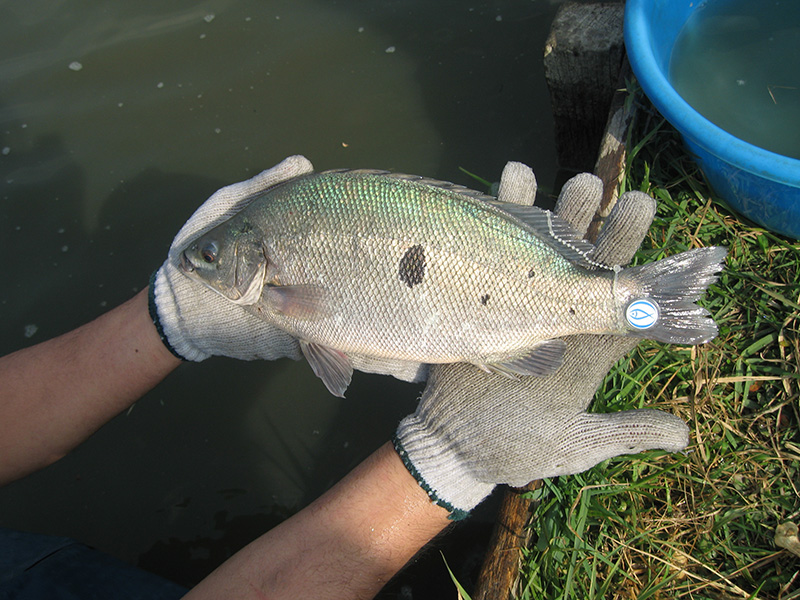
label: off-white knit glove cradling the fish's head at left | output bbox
[150,156,314,361]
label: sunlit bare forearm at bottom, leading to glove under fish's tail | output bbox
[186,444,449,600]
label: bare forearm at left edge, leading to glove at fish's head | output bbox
[0,290,180,485]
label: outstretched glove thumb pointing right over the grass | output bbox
[536,409,689,477]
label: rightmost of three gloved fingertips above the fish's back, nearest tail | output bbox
[592,191,656,265]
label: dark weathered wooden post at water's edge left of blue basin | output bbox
[544,2,624,172]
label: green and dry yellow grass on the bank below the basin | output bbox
[517,96,800,600]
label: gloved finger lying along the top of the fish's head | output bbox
[172,155,314,251]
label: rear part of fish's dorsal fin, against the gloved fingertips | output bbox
[491,202,614,270]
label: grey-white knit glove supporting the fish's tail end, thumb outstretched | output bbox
[394,163,689,519]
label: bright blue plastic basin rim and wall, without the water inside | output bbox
[625,0,800,239]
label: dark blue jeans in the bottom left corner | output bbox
[0,527,189,600]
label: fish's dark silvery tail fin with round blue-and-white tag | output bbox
[620,247,728,344]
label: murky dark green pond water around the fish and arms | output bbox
[0,0,568,597]
